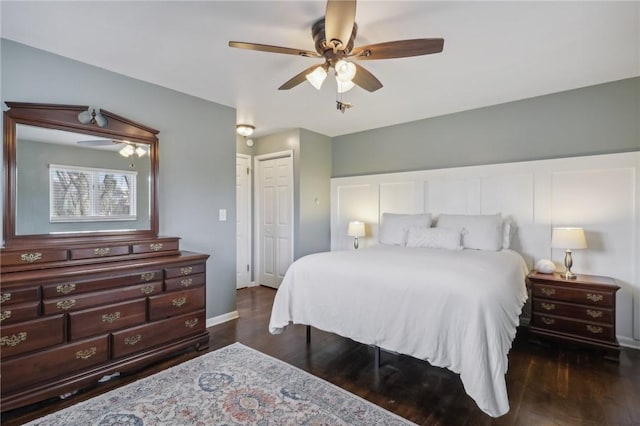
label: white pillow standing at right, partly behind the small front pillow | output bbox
[436,213,503,251]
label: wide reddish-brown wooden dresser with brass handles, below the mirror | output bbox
[0,238,209,411]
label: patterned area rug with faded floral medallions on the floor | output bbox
[29,343,413,426]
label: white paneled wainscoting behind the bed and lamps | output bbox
[331,151,640,349]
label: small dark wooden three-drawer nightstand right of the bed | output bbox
[527,272,620,361]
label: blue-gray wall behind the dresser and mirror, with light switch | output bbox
[0,39,236,317]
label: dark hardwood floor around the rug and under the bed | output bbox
[2,287,640,426]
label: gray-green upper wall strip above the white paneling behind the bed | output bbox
[332,78,640,177]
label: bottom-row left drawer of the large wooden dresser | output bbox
[1,335,109,395]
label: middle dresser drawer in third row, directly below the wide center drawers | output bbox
[69,299,146,340]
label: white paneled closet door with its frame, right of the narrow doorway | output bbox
[256,152,293,288]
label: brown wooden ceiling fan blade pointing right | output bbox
[350,38,444,61]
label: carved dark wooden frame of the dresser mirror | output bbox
[3,102,159,248]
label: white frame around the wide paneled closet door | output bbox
[253,149,295,285]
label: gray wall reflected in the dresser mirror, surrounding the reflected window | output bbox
[16,139,151,235]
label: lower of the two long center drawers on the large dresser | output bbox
[42,281,162,315]
